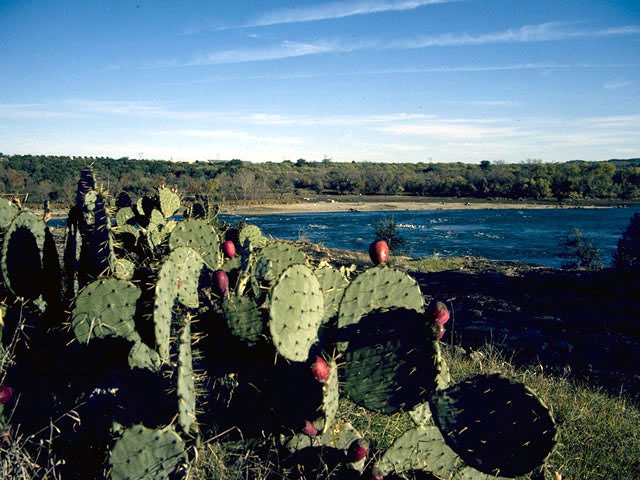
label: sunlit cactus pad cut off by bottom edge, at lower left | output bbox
[109,425,185,480]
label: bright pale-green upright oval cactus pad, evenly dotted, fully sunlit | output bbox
[269,265,324,362]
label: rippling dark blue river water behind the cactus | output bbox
[222,207,640,267]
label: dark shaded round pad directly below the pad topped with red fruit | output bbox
[343,309,443,413]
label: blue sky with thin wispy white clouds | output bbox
[0,0,640,162]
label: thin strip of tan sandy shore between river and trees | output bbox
[221,201,611,215]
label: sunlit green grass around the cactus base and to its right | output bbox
[192,345,640,480]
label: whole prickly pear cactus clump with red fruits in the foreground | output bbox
[0,169,556,480]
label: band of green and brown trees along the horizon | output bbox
[0,153,640,203]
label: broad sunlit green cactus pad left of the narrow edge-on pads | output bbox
[71,278,141,344]
